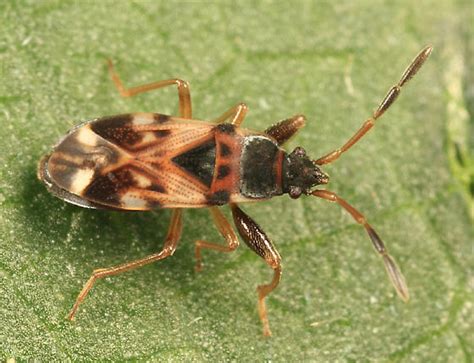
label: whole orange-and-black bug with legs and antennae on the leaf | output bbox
[38,46,432,336]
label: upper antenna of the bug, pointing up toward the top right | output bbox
[315,46,433,165]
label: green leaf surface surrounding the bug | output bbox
[0,0,474,362]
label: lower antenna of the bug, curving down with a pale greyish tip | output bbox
[311,190,409,302]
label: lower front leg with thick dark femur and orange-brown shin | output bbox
[231,204,281,336]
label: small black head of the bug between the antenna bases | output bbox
[282,146,329,198]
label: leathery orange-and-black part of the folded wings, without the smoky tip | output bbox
[80,113,215,210]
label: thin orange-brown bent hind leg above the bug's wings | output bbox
[107,59,192,118]
